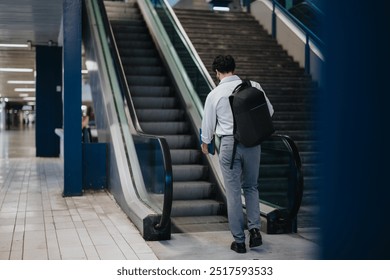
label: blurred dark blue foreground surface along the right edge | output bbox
[319,0,390,259]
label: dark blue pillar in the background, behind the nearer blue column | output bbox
[35,46,62,157]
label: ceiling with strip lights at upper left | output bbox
[0,0,63,106]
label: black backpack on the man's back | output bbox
[229,80,275,168]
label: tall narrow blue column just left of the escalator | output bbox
[63,0,82,196]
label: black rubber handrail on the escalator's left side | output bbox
[97,0,173,230]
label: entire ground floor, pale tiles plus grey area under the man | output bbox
[0,124,319,260]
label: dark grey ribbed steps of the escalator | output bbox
[105,1,227,232]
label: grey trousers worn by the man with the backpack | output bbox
[219,136,261,243]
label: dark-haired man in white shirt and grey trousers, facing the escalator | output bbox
[201,55,274,253]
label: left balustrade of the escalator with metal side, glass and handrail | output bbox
[83,0,172,240]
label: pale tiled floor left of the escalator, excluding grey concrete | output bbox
[0,126,156,260]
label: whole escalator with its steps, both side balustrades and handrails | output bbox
[83,0,303,240]
